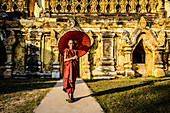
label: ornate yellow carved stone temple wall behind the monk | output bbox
[0,0,170,78]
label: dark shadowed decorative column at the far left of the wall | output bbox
[3,31,16,78]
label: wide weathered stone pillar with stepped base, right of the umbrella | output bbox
[93,33,116,76]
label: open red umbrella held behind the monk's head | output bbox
[58,31,90,57]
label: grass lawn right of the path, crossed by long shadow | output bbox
[85,77,170,113]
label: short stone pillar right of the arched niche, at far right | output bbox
[154,47,165,77]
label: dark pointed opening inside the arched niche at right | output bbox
[133,39,145,64]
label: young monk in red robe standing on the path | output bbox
[63,39,78,103]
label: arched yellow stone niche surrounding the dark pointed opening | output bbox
[132,29,155,76]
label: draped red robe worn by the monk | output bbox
[63,48,78,93]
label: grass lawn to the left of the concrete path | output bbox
[0,78,57,113]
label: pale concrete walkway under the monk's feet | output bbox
[34,78,103,113]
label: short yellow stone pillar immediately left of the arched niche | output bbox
[124,46,135,77]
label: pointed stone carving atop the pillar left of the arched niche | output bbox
[120,30,132,45]
